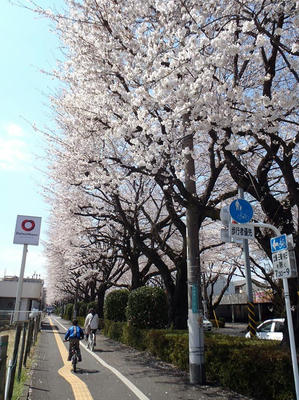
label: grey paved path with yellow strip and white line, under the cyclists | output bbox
[28,317,254,400]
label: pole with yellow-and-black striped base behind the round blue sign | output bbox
[238,187,256,337]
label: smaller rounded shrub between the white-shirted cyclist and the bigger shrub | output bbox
[104,289,129,322]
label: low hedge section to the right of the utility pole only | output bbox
[205,334,294,400]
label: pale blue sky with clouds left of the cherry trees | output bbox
[0,0,62,279]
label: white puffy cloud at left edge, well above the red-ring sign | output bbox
[0,123,31,171]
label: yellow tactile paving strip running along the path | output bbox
[49,318,93,400]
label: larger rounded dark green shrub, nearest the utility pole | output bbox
[126,286,168,329]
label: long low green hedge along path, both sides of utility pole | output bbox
[104,320,295,400]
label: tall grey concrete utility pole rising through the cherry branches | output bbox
[183,119,206,385]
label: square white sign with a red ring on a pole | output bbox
[13,215,41,246]
